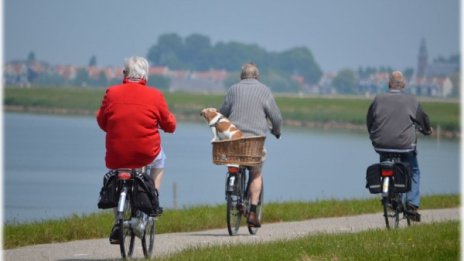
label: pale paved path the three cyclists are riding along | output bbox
[4,208,460,261]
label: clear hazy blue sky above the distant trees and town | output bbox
[3,0,460,72]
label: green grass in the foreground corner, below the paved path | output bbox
[157,221,460,261]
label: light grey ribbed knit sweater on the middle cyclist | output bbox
[220,79,282,137]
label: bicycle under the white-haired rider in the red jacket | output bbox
[113,167,156,259]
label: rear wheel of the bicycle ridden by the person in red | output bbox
[118,197,135,258]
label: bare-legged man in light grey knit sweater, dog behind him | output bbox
[220,63,282,227]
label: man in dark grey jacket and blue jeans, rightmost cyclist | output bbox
[367,71,432,218]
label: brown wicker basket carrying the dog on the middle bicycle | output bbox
[213,136,266,166]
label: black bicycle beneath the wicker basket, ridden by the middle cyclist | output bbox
[226,165,264,236]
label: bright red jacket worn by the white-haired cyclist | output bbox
[97,80,176,169]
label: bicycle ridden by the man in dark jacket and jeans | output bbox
[380,153,420,229]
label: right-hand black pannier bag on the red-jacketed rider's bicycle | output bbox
[132,173,159,216]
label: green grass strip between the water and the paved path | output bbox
[3,195,460,249]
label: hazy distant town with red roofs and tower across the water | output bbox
[3,39,460,98]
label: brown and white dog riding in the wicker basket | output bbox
[200,108,243,142]
